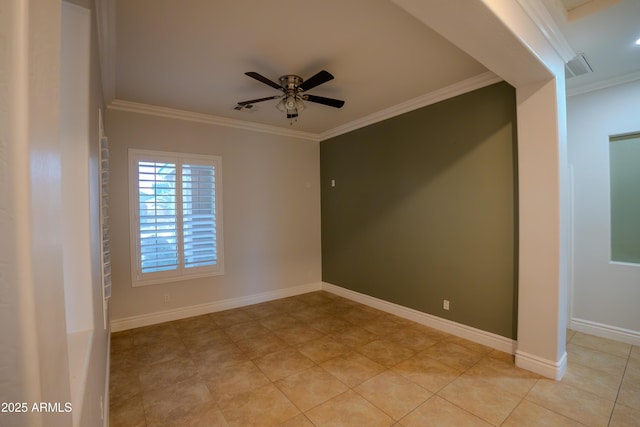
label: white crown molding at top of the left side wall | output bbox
[95,0,116,104]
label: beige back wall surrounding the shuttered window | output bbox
[106,109,321,330]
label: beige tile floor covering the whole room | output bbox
[110,292,640,427]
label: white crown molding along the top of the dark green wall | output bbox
[319,71,502,141]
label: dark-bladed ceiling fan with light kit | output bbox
[234,70,344,123]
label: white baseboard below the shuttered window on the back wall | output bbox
[111,283,322,332]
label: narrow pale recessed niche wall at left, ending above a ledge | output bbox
[60,2,93,333]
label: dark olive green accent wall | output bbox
[320,82,517,339]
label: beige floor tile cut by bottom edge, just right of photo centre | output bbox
[306,390,393,427]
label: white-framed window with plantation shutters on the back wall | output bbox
[129,149,224,286]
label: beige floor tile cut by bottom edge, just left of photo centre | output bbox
[219,384,300,427]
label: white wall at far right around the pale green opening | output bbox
[567,81,640,345]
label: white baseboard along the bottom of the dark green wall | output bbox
[322,282,516,354]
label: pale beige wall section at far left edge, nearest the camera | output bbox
[0,0,71,426]
